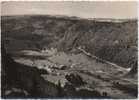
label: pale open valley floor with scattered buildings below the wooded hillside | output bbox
[13,49,137,99]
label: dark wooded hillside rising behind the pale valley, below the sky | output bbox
[1,15,138,70]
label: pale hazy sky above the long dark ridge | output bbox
[1,1,138,19]
